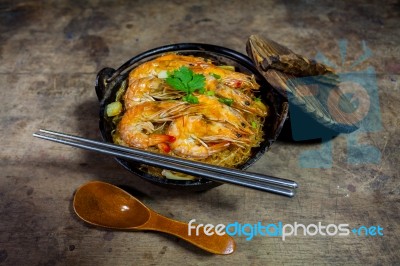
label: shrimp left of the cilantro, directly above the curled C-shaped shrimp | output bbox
[124,77,182,109]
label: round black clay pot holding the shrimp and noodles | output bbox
[96,43,288,191]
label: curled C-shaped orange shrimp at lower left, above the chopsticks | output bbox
[117,101,187,152]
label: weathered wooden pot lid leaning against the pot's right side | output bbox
[246,35,362,140]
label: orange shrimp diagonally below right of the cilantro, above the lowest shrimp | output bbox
[188,95,253,134]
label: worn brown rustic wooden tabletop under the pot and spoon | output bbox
[0,0,400,265]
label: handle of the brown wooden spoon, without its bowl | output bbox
[139,211,236,255]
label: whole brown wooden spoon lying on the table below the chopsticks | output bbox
[73,181,236,254]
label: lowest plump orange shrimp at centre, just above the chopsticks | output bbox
[166,115,248,159]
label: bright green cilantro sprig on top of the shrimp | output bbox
[166,66,206,103]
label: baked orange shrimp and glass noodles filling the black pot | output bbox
[106,53,268,180]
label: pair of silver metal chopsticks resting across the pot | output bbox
[33,129,298,197]
